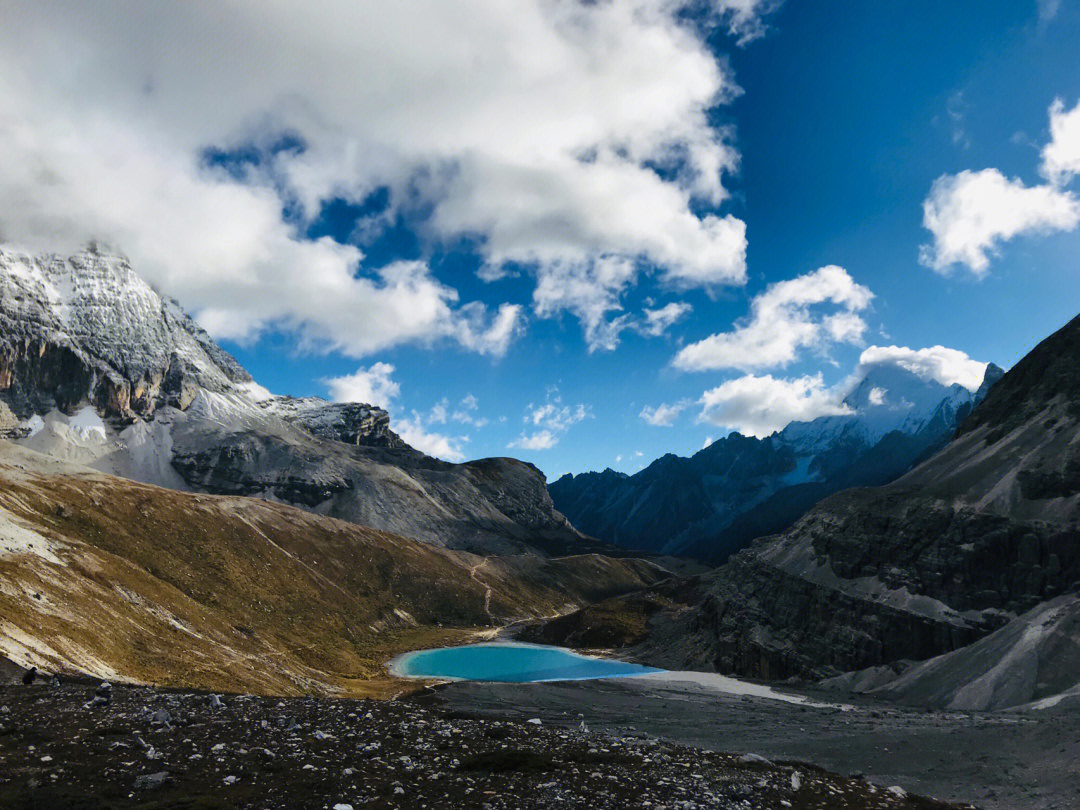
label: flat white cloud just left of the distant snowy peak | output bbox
[699,374,851,436]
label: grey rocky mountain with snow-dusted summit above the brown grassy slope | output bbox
[0,246,598,553]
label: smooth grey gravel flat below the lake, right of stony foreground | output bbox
[420,678,1080,810]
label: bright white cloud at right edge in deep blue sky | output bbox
[920,168,1080,278]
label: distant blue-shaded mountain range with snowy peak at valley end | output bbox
[549,364,1002,563]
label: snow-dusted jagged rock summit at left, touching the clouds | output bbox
[0,244,252,418]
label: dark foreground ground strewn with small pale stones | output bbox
[0,684,972,810]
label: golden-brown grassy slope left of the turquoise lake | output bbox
[0,444,661,696]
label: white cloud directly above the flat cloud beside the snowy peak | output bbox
[674,265,874,370]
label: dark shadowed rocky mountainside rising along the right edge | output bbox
[544,318,1080,707]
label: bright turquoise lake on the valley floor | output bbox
[393,643,662,684]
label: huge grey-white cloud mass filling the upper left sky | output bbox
[0,0,775,356]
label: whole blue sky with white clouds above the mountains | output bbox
[0,0,1080,477]
